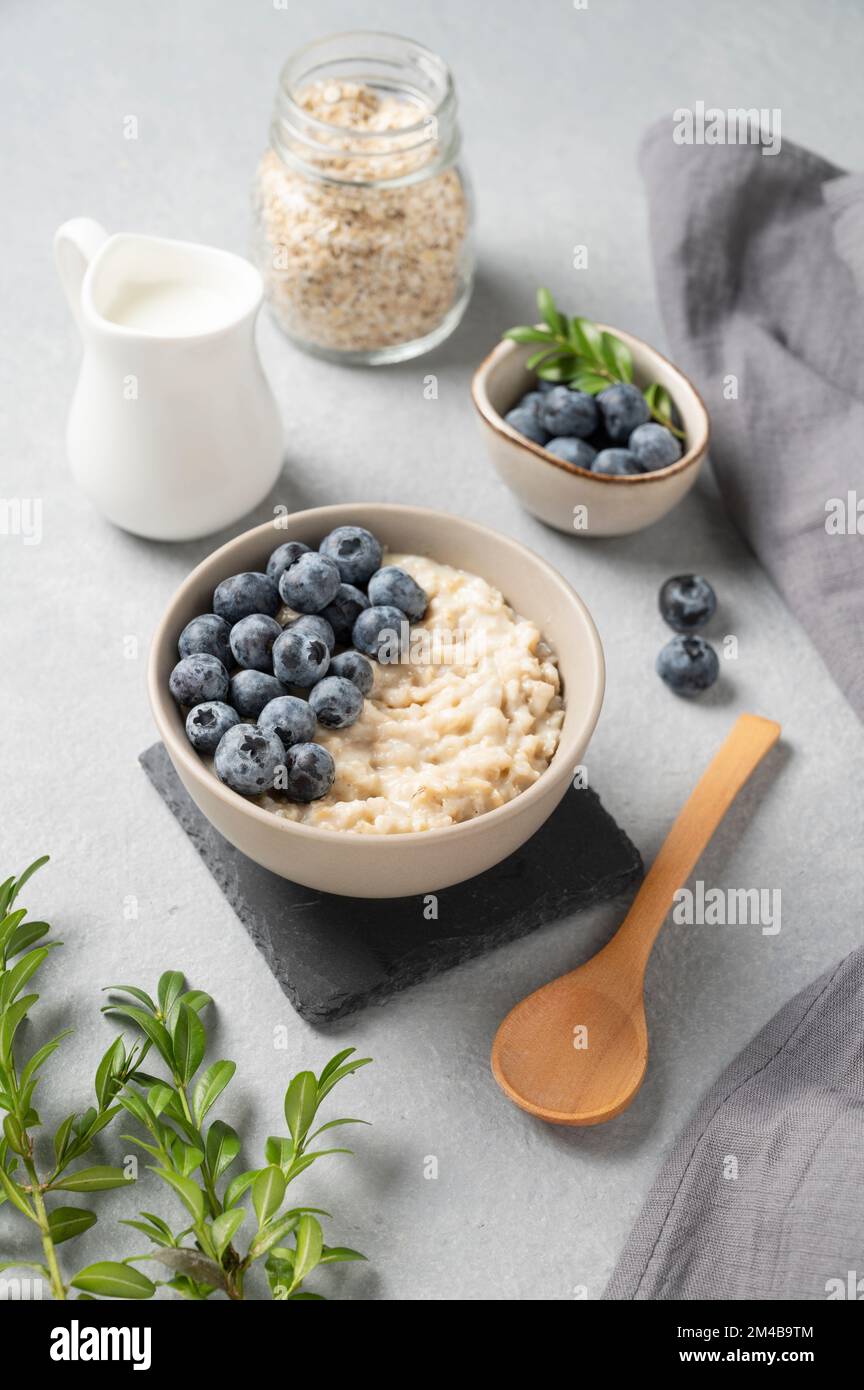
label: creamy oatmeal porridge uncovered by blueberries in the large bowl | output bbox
[257,555,564,834]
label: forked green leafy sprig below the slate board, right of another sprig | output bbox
[103,970,371,1300]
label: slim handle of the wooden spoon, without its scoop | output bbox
[606,714,781,970]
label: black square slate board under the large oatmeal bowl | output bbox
[140,744,642,1023]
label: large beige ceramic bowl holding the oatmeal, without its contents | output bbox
[147,503,604,898]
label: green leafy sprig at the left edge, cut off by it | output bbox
[0,855,143,1298]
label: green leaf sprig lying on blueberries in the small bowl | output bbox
[504,289,685,439]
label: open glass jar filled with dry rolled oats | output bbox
[254,33,474,363]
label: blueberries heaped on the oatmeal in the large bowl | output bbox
[168,525,428,802]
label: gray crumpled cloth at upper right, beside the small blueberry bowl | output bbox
[642,127,864,719]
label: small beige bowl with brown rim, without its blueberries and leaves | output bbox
[471,324,708,537]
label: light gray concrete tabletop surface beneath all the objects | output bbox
[0,0,864,1300]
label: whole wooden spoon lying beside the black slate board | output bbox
[492,714,781,1125]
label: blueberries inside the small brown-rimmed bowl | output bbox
[504,381,681,477]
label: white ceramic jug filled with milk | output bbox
[54,217,282,541]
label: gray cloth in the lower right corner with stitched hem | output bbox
[603,948,864,1300]
